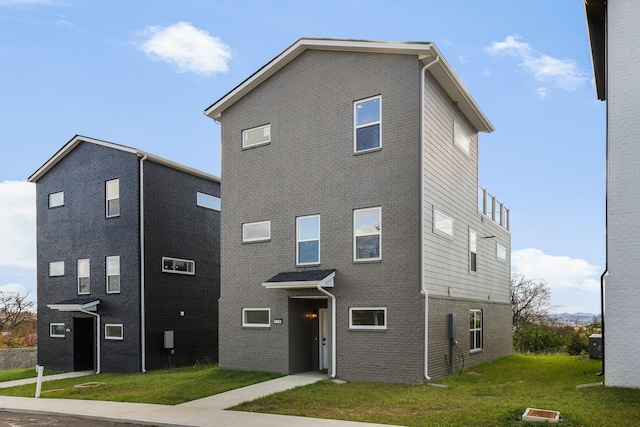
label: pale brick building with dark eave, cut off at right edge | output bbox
[584,0,640,388]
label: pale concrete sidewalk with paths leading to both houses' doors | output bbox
[0,372,400,427]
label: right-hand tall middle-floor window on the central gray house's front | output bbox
[353,207,382,261]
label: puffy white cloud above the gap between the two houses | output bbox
[138,22,231,76]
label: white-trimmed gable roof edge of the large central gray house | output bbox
[204,38,494,132]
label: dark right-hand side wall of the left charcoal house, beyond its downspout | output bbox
[144,161,220,369]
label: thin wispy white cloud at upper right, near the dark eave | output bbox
[486,35,589,97]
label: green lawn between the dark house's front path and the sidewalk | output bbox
[0,365,279,405]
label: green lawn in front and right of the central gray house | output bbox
[233,355,640,427]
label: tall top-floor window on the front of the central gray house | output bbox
[353,96,382,153]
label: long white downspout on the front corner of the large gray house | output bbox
[420,53,440,381]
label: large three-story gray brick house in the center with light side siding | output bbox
[205,39,512,383]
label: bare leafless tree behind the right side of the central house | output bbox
[511,274,551,329]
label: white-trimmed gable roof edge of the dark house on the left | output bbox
[27,135,220,183]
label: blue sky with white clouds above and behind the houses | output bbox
[0,0,605,313]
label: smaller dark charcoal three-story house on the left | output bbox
[29,136,220,372]
